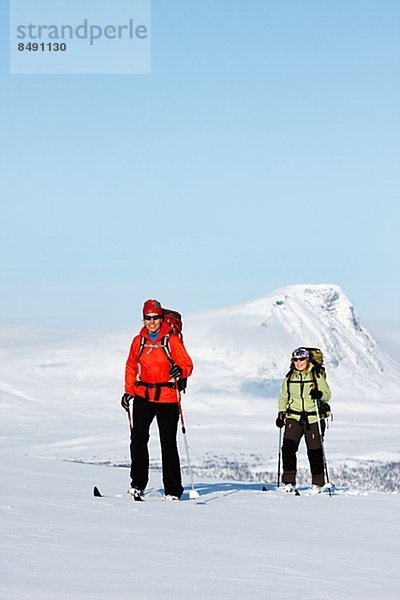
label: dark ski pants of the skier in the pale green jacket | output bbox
[282,418,325,486]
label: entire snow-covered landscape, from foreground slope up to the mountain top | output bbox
[0,286,400,600]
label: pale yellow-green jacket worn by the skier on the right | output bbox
[278,364,331,423]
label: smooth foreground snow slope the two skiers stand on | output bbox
[0,452,400,600]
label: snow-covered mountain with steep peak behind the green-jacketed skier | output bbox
[188,284,400,393]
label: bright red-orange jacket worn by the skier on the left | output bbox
[125,322,193,402]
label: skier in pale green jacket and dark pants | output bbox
[276,348,331,492]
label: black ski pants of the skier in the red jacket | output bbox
[130,396,183,498]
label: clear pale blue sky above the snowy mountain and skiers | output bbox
[0,0,400,328]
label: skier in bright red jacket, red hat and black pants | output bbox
[121,300,193,500]
